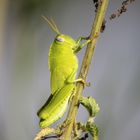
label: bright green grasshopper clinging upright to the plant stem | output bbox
[37,16,90,128]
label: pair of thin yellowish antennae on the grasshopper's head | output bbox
[41,15,60,34]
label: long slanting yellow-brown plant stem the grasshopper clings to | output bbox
[62,0,109,140]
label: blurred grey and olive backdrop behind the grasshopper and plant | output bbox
[0,0,140,140]
